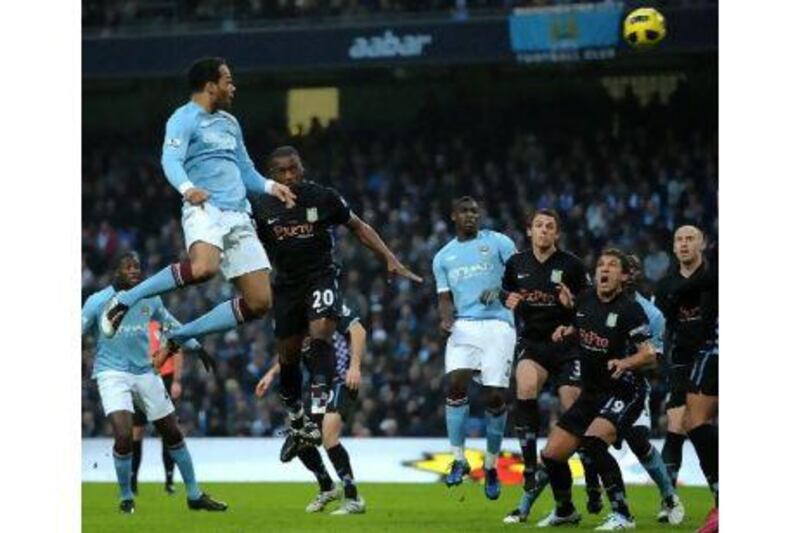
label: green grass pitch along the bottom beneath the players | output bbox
[82,482,713,533]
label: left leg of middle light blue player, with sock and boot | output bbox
[445,368,473,487]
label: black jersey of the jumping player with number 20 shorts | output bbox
[251,180,353,285]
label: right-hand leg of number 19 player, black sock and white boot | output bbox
[583,417,635,530]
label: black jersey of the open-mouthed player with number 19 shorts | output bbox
[575,291,651,393]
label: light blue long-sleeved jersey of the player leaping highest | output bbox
[161,101,266,213]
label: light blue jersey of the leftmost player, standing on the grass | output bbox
[81,285,185,377]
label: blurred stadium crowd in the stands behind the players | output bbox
[82,87,717,437]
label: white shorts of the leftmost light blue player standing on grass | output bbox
[97,370,175,422]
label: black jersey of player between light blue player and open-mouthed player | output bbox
[503,249,591,342]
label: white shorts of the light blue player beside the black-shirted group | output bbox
[444,320,517,388]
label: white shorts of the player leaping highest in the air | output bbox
[181,202,271,279]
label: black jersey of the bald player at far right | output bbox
[655,261,718,365]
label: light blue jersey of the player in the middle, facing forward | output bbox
[433,230,516,326]
